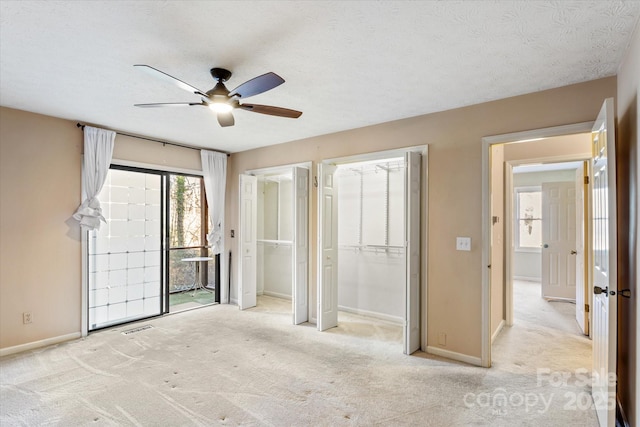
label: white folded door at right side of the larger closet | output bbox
[403,152,421,354]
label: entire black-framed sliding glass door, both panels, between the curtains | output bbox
[87,166,219,331]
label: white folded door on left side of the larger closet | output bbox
[317,163,338,331]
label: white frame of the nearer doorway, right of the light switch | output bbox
[480,121,594,368]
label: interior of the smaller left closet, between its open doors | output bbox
[256,172,293,300]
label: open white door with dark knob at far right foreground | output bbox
[591,98,618,427]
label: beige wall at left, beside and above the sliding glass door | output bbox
[0,107,201,349]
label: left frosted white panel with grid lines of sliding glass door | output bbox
[88,168,164,330]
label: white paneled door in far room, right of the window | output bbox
[542,182,576,300]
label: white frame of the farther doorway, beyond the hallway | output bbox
[504,155,589,326]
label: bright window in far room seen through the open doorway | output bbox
[515,187,542,251]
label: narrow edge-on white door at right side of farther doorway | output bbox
[574,162,589,335]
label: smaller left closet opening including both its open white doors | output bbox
[238,165,309,325]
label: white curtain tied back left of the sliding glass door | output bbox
[73,126,116,230]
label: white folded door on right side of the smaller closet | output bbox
[292,167,309,325]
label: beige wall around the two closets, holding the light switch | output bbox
[226,77,616,357]
